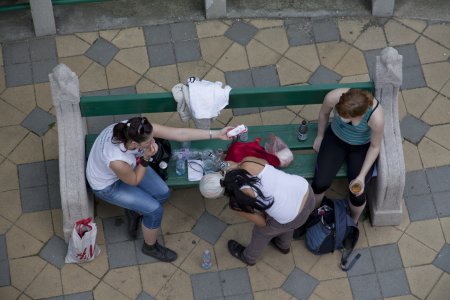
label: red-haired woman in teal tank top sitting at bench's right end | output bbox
[311,88,384,223]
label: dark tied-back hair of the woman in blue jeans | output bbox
[112,117,153,144]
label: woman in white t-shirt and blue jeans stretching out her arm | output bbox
[86,117,231,262]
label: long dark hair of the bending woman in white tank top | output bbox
[221,169,273,213]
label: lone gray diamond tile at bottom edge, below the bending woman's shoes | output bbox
[281,268,319,300]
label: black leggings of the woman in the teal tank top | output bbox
[311,126,374,206]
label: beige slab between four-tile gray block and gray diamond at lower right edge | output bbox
[398,234,436,267]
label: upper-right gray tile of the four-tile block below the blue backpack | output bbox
[370,244,403,272]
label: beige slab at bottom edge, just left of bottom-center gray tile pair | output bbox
[156,270,194,300]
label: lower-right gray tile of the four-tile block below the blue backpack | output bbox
[377,269,411,298]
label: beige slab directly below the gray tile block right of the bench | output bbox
[406,219,445,252]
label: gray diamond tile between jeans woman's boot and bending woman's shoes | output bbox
[192,212,227,245]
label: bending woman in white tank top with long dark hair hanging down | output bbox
[204,157,315,265]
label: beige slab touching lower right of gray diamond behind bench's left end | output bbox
[106,60,141,89]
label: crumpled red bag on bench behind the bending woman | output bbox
[225,138,280,167]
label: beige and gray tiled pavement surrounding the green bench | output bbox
[0,18,450,299]
